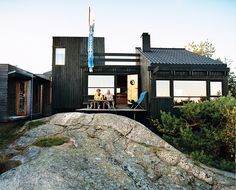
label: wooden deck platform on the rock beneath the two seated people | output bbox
[75,108,147,120]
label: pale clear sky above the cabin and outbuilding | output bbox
[0,0,236,73]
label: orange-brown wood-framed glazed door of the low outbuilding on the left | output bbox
[16,81,27,115]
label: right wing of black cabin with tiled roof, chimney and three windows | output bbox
[136,33,229,117]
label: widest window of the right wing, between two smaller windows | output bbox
[174,81,207,105]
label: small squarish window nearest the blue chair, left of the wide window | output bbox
[156,80,170,97]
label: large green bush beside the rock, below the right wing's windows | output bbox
[152,95,236,172]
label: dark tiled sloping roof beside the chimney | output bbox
[137,48,222,64]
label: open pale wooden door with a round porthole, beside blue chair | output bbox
[127,74,138,103]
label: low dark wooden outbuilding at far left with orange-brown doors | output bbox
[0,64,51,122]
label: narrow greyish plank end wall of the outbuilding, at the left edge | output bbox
[0,64,8,120]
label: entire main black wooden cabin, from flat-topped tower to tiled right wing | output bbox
[52,33,229,117]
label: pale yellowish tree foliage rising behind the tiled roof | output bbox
[186,40,215,58]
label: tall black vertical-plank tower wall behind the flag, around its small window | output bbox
[52,37,105,112]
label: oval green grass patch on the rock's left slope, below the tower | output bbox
[33,136,70,147]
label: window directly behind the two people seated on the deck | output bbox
[88,75,115,95]
